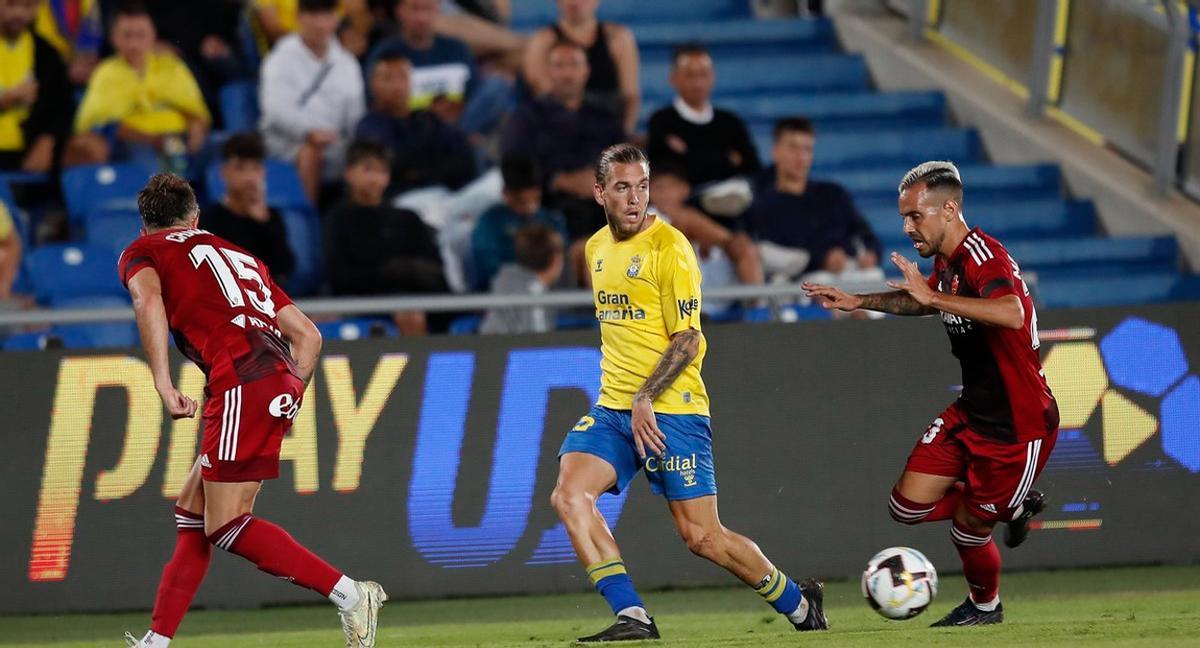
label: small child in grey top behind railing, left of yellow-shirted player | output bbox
[479,223,563,334]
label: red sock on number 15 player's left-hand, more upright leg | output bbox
[150,506,212,638]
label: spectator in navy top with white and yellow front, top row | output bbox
[367,0,512,133]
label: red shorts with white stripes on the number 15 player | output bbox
[200,373,304,481]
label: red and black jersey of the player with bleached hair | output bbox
[929,228,1058,443]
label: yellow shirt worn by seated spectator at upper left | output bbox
[76,52,211,134]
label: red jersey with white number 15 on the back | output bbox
[118,229,298,394]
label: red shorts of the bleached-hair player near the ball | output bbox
[905,403,1058,521]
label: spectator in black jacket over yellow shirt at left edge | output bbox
[0,0,71,173]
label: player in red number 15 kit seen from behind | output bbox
[118,174,388,648]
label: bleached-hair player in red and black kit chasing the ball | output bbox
[804,162,1058,626]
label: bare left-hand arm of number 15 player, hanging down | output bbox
[128,268,196,419]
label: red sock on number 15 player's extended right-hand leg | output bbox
[209,514,342,596]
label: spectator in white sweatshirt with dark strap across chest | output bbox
[259,0,366,203]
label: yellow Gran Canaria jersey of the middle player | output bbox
[586,218,708,416]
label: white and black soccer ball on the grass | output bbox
[863,547,937,620]
